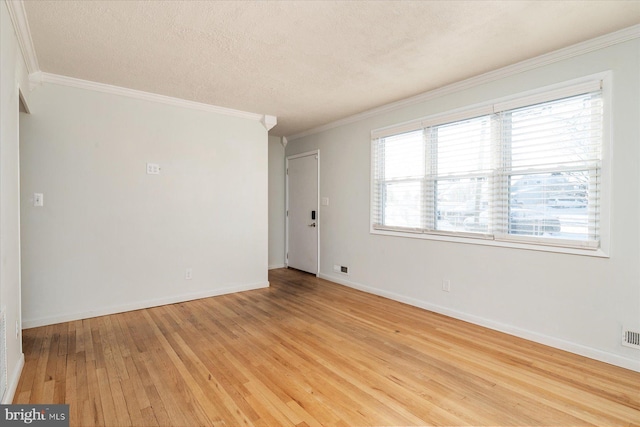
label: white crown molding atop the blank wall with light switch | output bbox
[29,72,277,124]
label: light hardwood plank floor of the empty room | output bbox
[14,269,640,426]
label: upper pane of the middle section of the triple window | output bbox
[433,116,492,176]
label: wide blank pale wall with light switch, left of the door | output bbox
[20,83,268,326]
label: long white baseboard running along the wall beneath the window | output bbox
[319,274,640,372]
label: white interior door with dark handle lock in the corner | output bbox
[287,151,319,274]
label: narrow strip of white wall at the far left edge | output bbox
[0,2,29,403]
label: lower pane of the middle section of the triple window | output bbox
[436,178,489,233]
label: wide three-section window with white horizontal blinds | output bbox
[371,80,604,254]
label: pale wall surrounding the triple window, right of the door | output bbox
[286,39,640,370]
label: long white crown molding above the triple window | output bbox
[287,25,640,141]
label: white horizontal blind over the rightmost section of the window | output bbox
[499,89,603,246]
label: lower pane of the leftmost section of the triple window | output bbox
[382,181,422,228]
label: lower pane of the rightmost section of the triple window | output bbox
[508,171,597,240]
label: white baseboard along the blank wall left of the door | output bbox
[22,282,269,329]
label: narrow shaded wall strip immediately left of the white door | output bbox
[269,136,285,268]
